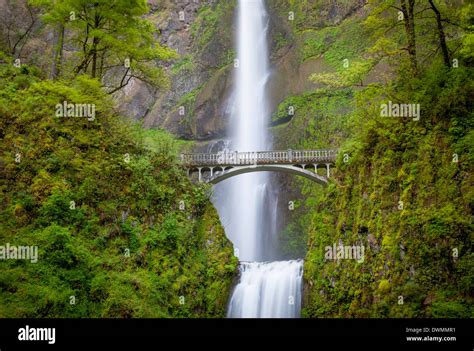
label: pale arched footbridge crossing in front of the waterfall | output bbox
[181,150,337,185]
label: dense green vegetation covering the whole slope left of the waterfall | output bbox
[0,2,237,317]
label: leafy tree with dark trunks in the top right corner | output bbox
[365,0,472,75]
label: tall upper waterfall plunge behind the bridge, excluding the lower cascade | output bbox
[216,0,277,261]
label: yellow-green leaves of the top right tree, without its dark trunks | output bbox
[364,0,466,75]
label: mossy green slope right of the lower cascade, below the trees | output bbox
[303,63,474,318]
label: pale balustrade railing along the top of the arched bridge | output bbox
[181,150,337,167]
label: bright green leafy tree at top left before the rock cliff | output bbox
[35,0,176,93]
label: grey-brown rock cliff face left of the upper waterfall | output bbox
[117,0,235,140]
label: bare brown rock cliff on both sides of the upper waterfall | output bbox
[117,0,364,141]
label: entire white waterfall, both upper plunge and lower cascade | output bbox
[214,0,303,318]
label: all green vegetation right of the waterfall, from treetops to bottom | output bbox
[268,1,474,317]
